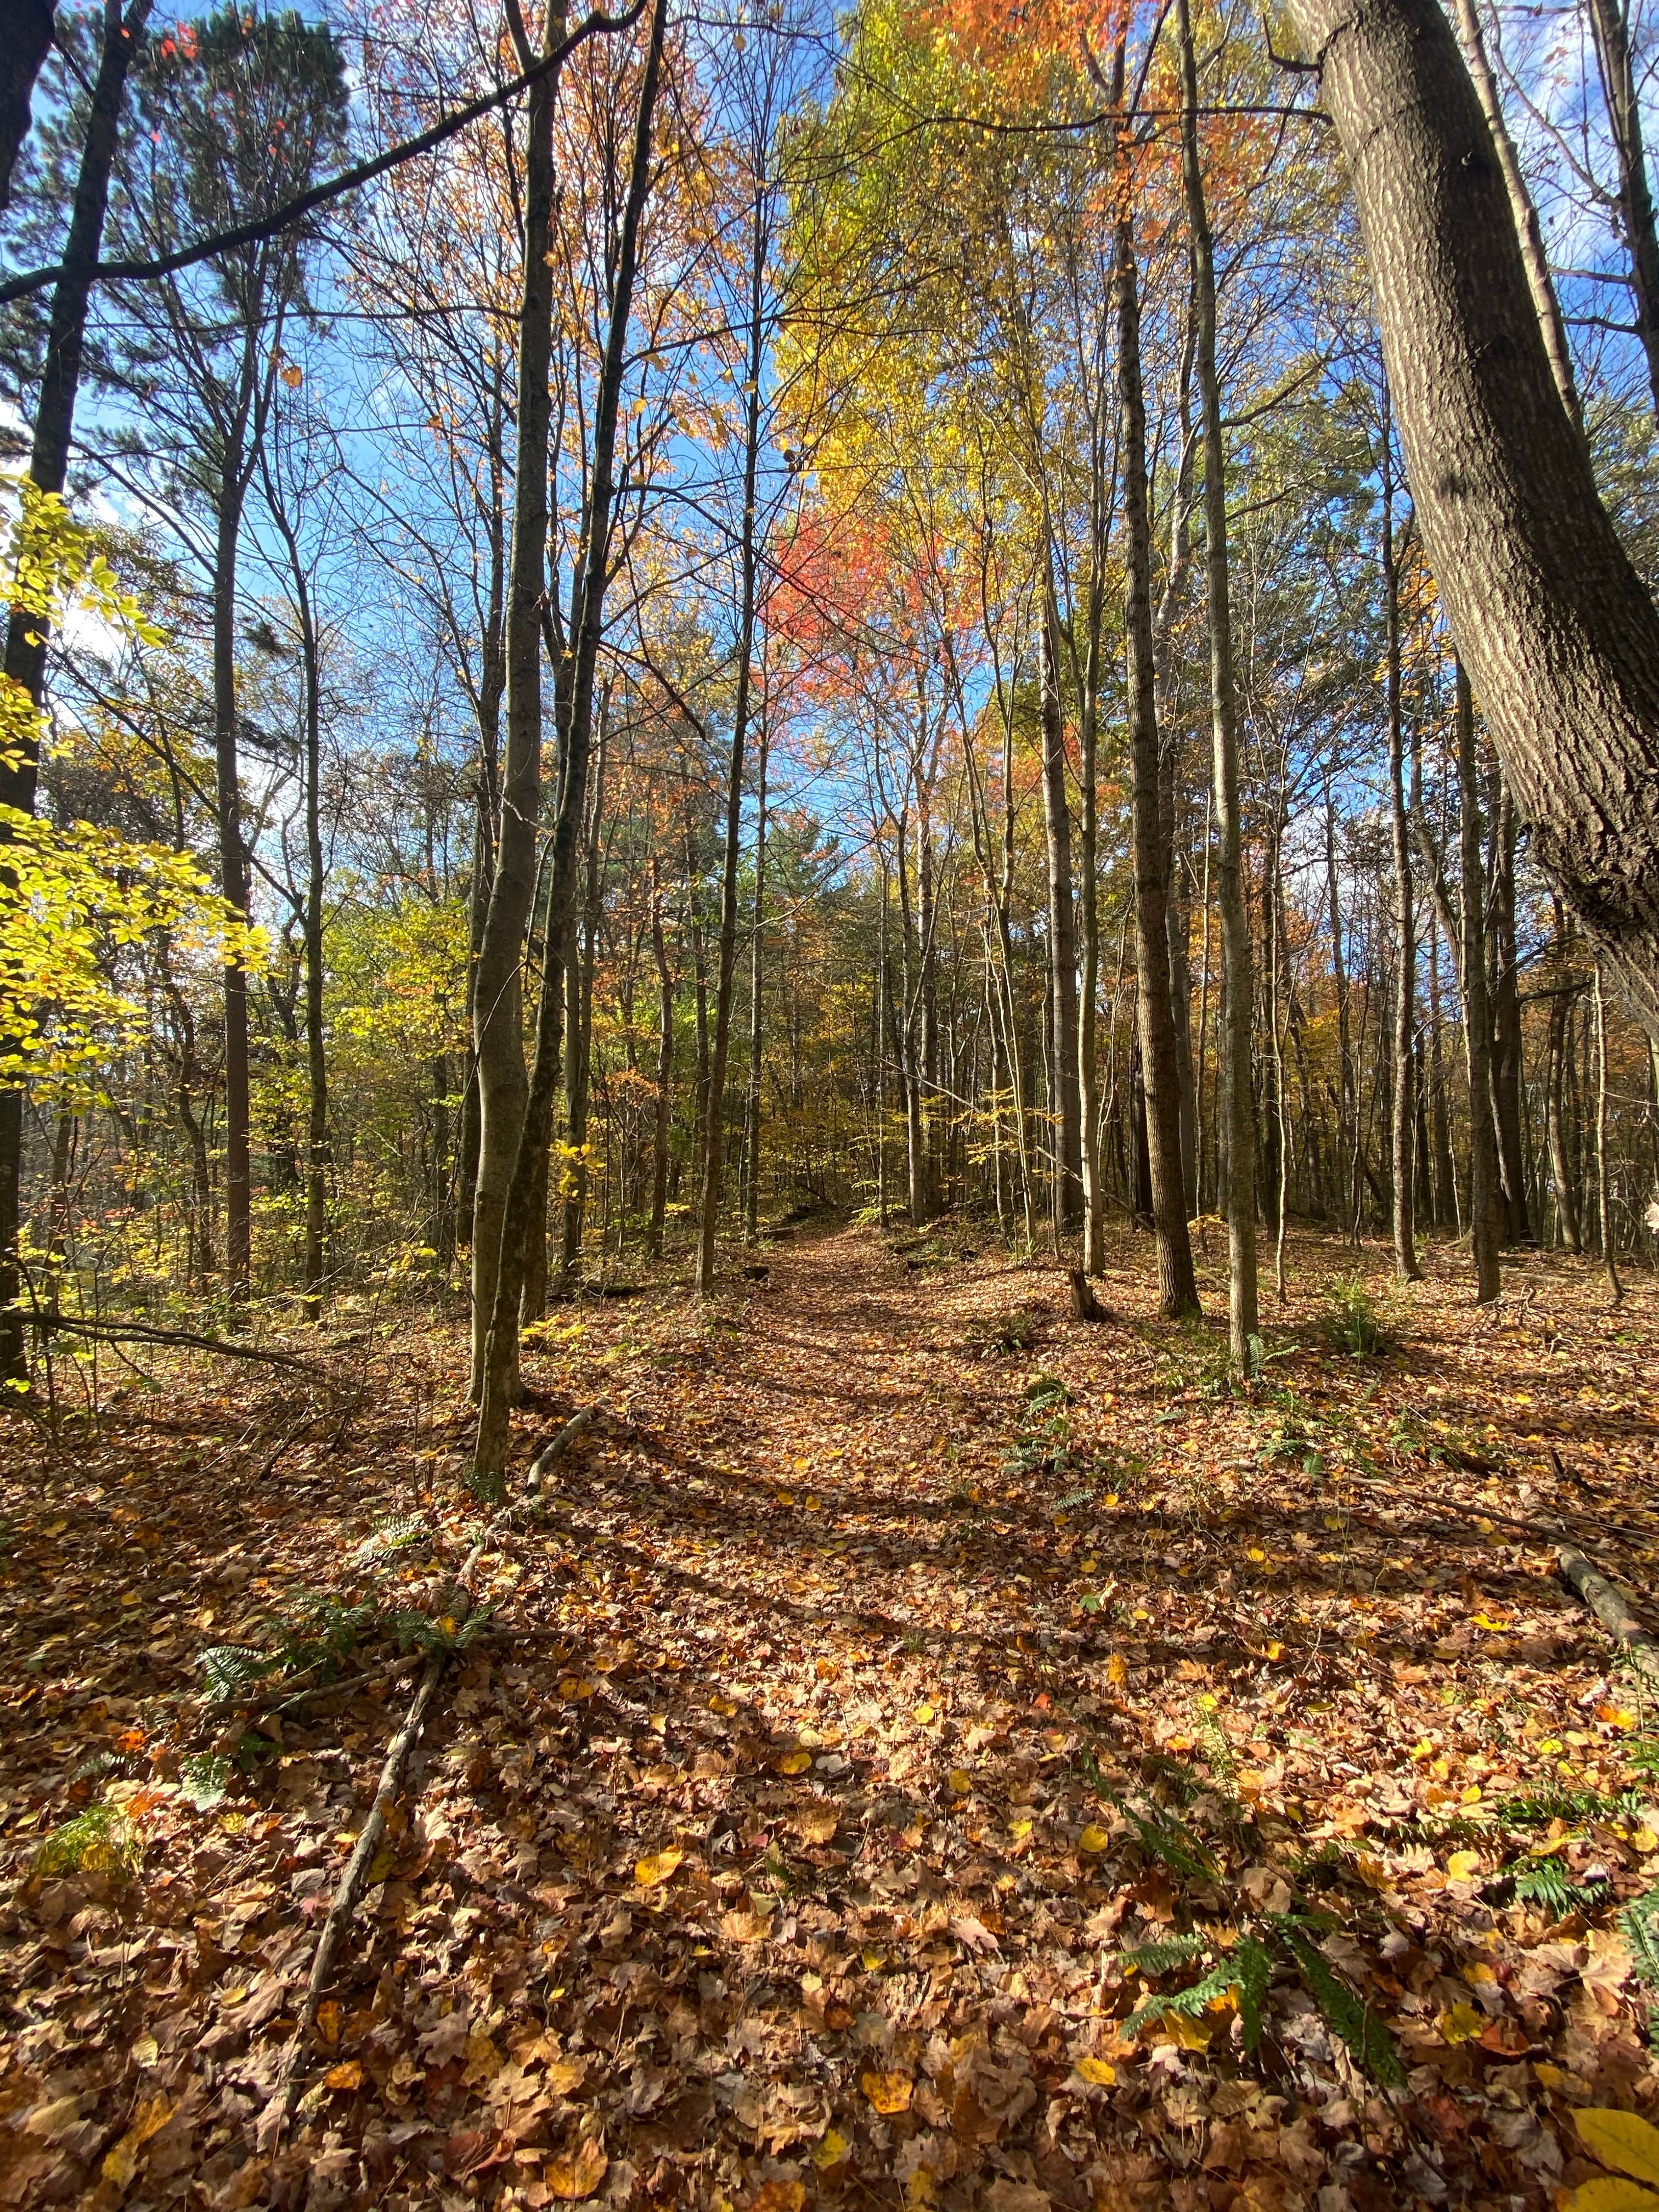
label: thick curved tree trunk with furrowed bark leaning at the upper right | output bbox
[1290,0,1659,1035]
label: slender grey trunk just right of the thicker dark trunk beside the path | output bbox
[1177,0,1256,1374]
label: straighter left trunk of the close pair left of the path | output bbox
[471,0,564,1398]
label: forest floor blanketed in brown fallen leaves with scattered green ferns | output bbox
[0,1226,1659,2212]
